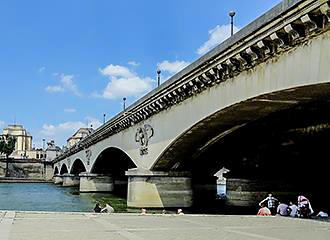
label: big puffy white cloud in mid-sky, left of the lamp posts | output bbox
[97,64,153,99]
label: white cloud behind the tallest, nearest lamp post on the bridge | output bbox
[197,24,239,55]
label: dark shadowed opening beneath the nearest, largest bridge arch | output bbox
[152,84,330,212]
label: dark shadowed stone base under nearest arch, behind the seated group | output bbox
[226,178,299,207]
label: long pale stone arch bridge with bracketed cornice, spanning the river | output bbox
[54,0,330,210]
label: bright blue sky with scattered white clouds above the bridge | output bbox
[0,0,280,147]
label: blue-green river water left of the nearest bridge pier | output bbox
[0,183,127,212]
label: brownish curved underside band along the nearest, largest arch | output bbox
[150,83,330,171]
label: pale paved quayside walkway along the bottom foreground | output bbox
[0,211,330,240]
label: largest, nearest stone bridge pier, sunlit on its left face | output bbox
[126,169,193,208]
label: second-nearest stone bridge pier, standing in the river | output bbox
[79,172,114,192]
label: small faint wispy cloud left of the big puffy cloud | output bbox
[46,73,82,96]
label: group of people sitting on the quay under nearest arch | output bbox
[257,193,314,218]
